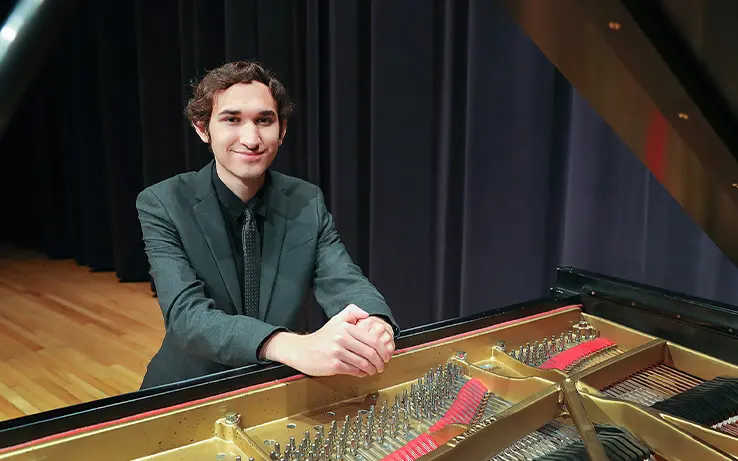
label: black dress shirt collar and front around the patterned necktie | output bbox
[213,168,269,299]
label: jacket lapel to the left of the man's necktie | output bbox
[193,161,243,313]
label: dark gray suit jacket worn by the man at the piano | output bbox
[136,161,399,388]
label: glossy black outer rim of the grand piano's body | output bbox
[0,267,738,453]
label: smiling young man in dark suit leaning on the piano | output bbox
[136,62,399,388]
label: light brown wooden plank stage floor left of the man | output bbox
[0,247,164,421]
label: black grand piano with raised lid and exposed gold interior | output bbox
[0,0,738,461]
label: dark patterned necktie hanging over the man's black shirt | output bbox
[241,207,261,318]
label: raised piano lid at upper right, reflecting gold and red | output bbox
[504,0,738,265]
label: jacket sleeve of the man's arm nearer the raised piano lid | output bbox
[313,189,400,336]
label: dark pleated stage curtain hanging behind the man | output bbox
[1,0,738,327]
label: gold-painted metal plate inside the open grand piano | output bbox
[0,306,738,461]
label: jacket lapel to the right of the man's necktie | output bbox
[259,171,288,320]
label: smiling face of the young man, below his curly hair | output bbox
[195,82,286,182]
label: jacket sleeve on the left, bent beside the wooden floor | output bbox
[136,189,285,367]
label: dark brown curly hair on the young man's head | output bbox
[185,61,294,131]
